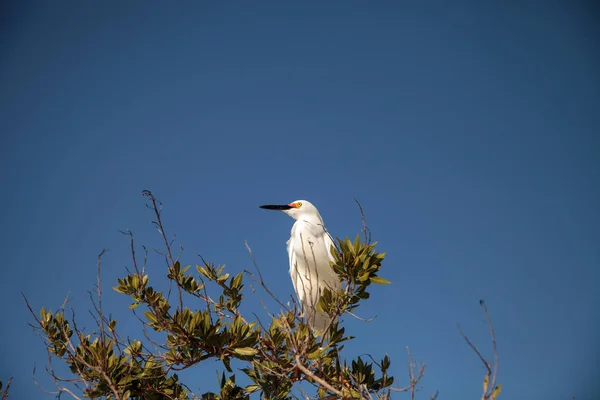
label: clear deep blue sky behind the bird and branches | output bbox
[0,1,600,400]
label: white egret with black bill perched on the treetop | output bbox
[260,200,341,335]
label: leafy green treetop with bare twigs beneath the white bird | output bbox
[21,191,500,400]
